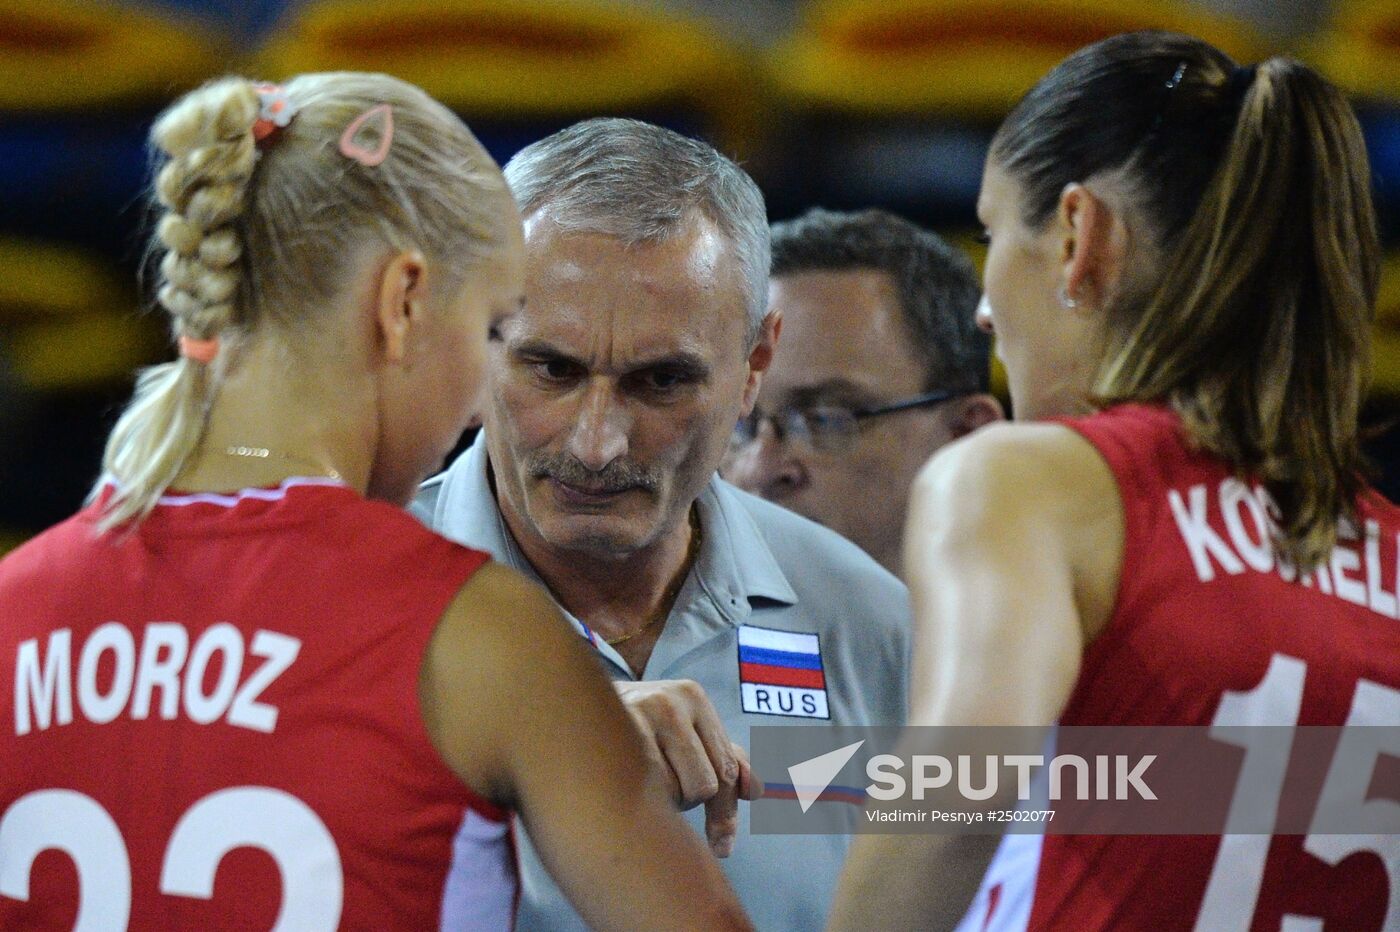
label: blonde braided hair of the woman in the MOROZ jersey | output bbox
[92,71,512,530]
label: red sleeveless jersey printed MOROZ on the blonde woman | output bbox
[0,479,517,931]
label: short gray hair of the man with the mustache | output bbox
[505,118,770,343]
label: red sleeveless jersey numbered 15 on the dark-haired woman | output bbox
[991,404,1400,932]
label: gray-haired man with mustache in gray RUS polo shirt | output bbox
[416,120,909,929]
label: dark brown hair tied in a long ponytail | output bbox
[993,34,1380,568]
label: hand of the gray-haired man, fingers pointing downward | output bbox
[613,680,763,858]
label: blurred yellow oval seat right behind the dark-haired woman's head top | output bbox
[771,0,1266,118]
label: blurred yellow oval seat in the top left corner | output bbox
[0,0,228,112]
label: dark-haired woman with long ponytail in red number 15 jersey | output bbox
[833,34,1400,932]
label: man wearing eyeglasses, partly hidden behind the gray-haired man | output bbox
[722,210,1002,574]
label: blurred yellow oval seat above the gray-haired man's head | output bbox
[258,0,748,118]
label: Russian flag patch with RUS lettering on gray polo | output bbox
[739,624,832,719]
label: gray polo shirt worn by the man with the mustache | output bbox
[413,437,910,932]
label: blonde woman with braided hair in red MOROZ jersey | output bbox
[0,73,746,931]
